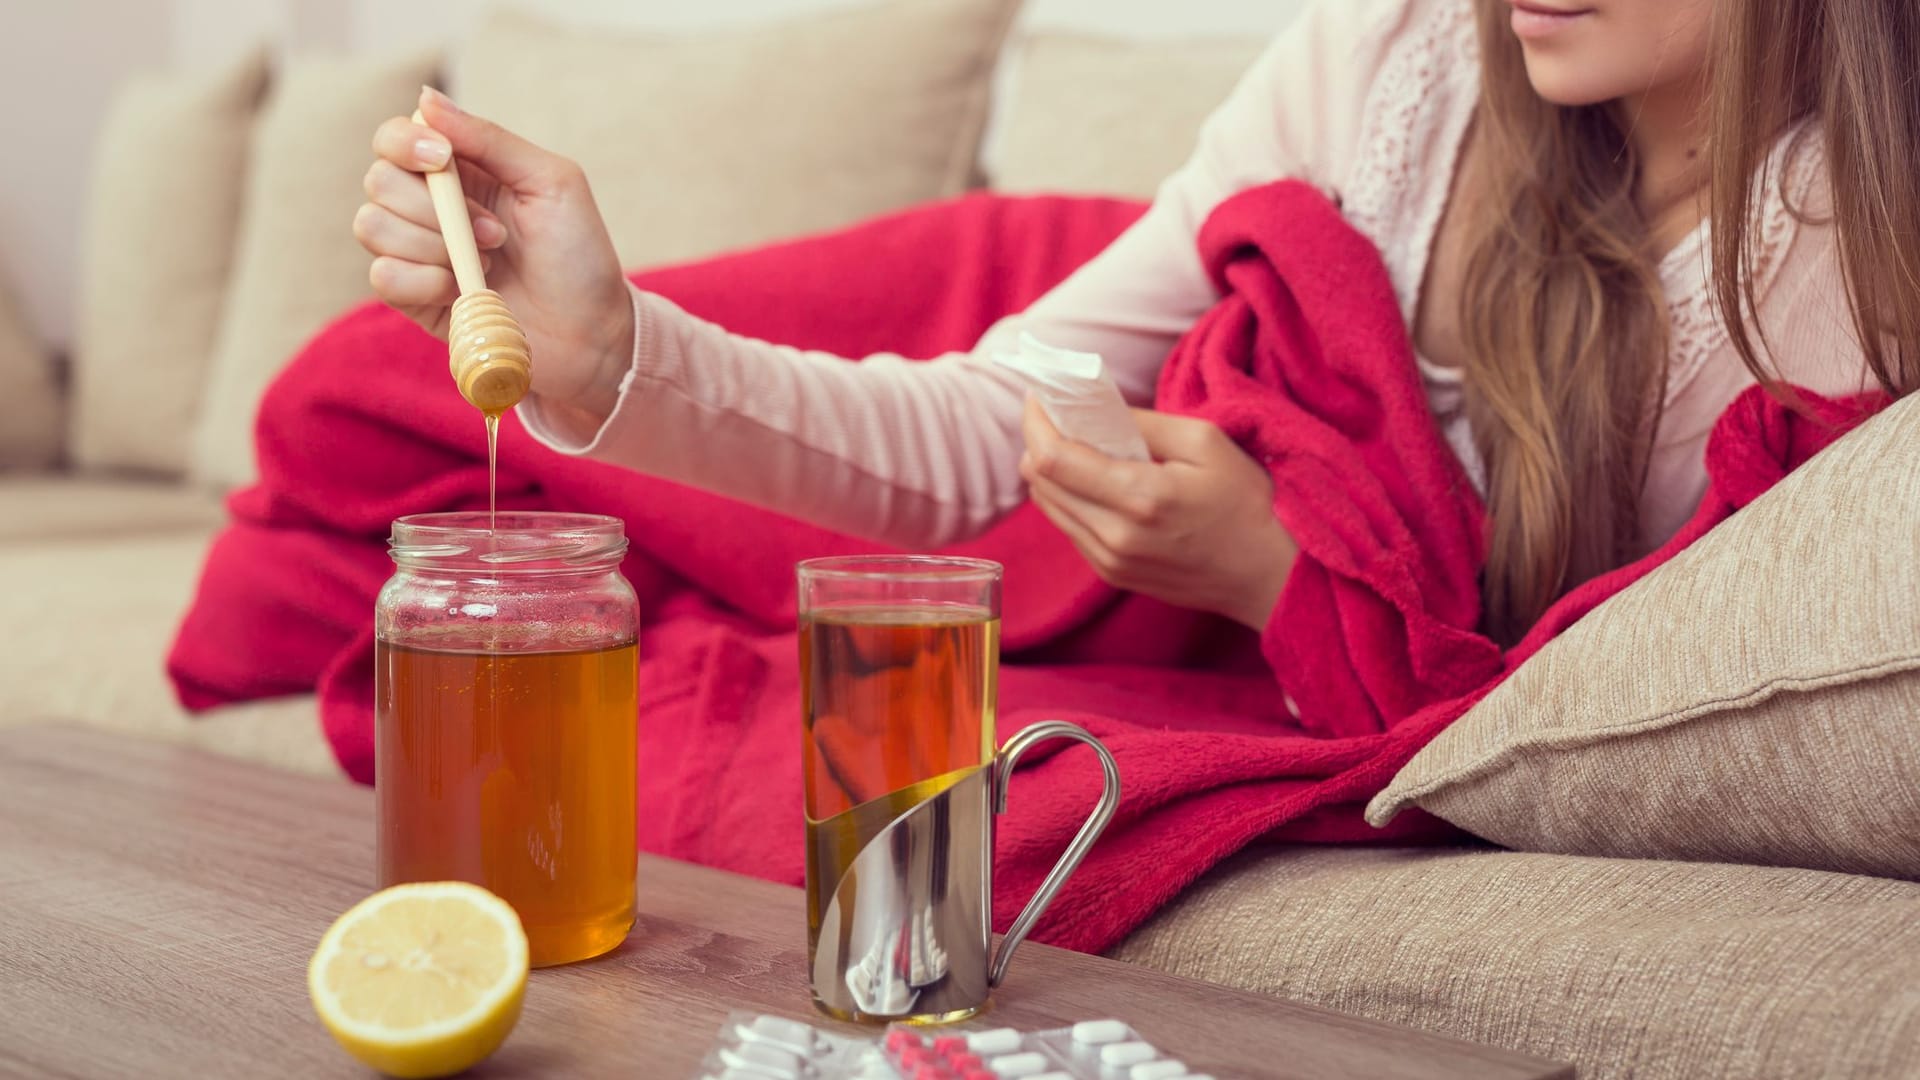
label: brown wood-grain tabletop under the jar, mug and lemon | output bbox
[0,726,1572,1080]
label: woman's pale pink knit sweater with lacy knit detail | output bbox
[520,0,1866,548]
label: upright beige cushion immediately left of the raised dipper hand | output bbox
[192,54,438,488]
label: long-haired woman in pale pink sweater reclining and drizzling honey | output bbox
[353,0,1920,640]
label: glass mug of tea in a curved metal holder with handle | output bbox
[799,555,1119,1024]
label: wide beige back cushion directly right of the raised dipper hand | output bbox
[453,0,1018,265]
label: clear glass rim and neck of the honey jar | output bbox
[388,509,626,573]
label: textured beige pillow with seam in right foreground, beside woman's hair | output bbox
[1367,390,1920,878]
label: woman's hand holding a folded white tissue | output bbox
[1020,400,1300,630]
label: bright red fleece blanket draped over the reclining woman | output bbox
[169,183,1866,949]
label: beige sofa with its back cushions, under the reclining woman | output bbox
[0,0,1920,1078]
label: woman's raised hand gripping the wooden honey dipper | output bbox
[353,88,634,419]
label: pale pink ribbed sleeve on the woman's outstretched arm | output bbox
[518,0,1402,548]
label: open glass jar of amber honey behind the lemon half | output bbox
[374,511,639,967]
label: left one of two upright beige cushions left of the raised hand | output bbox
[69,50,267,475]
